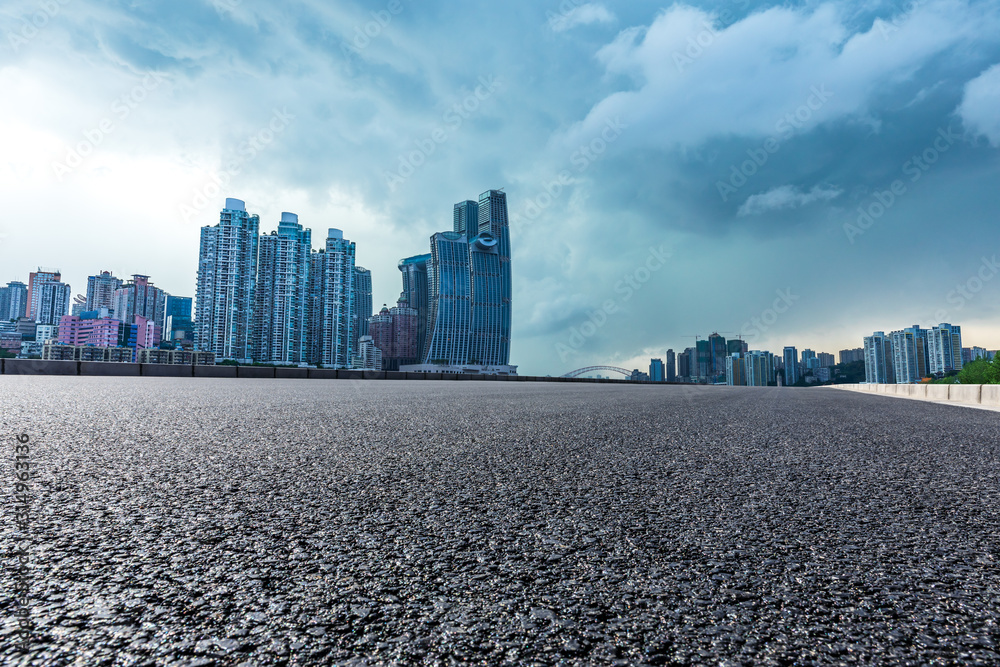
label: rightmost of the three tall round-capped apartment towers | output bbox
[309,229,355,368]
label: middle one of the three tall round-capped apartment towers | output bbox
[251,213,312,364]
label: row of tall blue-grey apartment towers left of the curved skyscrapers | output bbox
[194,199,372,368]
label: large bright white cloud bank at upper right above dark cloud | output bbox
[565,0,1000,149]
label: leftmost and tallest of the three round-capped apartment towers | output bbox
[195,199,260,361]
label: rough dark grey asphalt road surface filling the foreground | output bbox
[0,377,1000,665]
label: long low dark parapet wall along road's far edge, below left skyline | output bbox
[0,359,656,384]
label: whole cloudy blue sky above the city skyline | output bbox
[0,0,1000,374]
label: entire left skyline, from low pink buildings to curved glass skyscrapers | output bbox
[0,190,517,374]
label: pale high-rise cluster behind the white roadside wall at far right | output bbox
[864,323,995,384]
